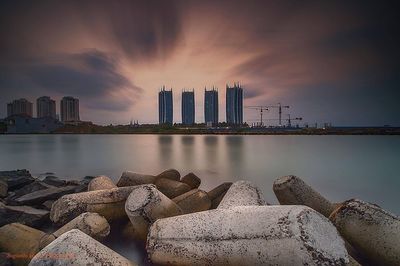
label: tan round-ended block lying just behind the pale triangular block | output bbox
[41,212,110,248]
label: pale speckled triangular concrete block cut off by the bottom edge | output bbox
[29,229,136,266]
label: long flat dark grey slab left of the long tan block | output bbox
[14,186,76,205]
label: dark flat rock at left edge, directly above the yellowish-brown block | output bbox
[0,203,49,227]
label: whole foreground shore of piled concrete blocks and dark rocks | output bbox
[0,169,400,265]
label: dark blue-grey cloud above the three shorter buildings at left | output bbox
[0,50,143,115]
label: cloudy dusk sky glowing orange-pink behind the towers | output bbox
[0,0,400,126]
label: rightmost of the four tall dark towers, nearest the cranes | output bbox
[226,83,243,125]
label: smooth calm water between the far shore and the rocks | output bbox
[0,135,400,213]
